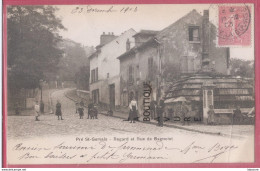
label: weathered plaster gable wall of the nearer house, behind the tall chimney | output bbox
[156,10,227,74]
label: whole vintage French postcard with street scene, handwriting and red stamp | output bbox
[4,3,259,166]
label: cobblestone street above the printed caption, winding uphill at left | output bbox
[8,89,197,138]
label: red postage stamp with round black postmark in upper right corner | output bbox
[218,5,251,46]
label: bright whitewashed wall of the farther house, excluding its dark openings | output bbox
[90,29,136,106]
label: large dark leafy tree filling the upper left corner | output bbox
[7,6,65,89]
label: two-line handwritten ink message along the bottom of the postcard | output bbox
[9,136,244,164]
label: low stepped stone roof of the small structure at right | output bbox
[166,75,254,101]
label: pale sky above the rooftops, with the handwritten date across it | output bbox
[56,4,254,60]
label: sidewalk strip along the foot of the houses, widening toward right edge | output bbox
[64,90,254,138]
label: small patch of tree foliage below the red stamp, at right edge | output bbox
[230,58,254,78]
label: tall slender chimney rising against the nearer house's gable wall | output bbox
[202,10,210,72]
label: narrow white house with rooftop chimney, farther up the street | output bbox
[89,29,136,108]
